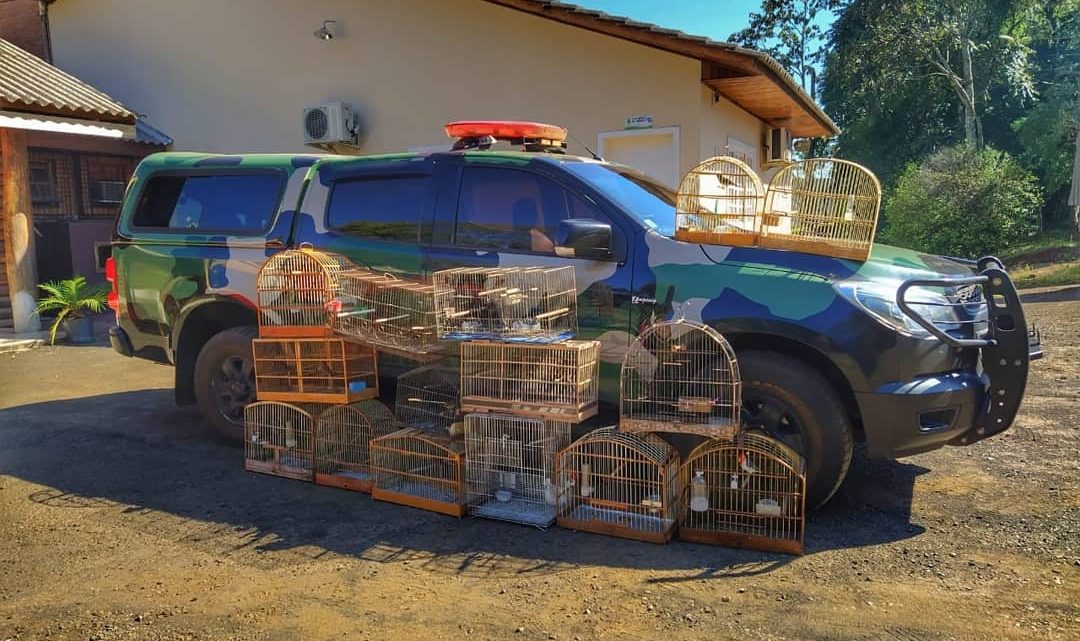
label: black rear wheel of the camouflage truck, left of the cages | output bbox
[194,325,258,444]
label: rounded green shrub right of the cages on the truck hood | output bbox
[881,145,1042,257]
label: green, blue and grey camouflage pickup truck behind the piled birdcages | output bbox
[108,144,1039,505]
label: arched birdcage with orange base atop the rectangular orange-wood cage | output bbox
[255,247,354,337]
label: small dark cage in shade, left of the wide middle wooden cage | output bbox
[394,363,461,435]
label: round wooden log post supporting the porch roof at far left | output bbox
[0,128,41,333]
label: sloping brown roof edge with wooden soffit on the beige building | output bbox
[485,0,840,137]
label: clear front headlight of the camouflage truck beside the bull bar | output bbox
[834,281,964,338]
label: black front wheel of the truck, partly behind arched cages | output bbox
[738,350,854,508]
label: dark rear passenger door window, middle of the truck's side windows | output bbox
[326,176,430,243]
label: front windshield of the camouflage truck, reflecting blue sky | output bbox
[563,162,675,236]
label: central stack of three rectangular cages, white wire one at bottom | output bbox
[434,267,599,528]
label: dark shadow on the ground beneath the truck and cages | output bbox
[0,390,927,582]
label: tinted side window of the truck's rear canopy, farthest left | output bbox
[132,173,282,232]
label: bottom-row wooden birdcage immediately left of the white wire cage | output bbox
[372,427,467,517]
